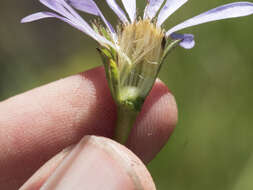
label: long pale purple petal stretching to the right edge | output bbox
[166,2,253,36]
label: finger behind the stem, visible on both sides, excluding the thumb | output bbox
[0,68,177,190]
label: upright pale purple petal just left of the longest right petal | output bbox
[157,0,188,26]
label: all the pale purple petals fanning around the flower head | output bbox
[21,0,253,49]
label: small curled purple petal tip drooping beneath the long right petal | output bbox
[170,33,195,49]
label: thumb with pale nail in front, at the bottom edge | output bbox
[20,136,155,190]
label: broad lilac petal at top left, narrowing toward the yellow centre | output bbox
[66,0,116,35]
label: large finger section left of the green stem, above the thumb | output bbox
[0,68,116,190]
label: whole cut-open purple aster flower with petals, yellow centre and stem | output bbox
[22,0,253,142]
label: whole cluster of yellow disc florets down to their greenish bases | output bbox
[117,20,165,96]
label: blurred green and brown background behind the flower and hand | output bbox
[0,0,253,190]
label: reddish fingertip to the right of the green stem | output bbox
[127,80,178,163]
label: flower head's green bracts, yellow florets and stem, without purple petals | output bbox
[94,20,180,143]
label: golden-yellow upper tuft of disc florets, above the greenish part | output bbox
[119,20,164,64]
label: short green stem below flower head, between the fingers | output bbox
[114,105,139,144]
